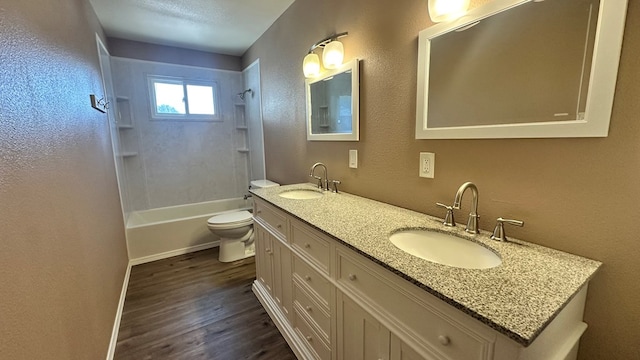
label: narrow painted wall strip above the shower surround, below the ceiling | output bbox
[108,38,242,71]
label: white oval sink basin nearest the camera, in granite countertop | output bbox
[389,230,502,269]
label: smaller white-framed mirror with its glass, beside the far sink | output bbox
[305,59,360,141]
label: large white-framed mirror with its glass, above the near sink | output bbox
[416,0,627,139]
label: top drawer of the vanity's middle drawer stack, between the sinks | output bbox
[291,221,331,274]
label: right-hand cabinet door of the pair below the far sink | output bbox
[269,234,293,322]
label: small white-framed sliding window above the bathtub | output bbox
[149,76,220,121]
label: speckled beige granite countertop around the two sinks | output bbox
[251,184,601,346]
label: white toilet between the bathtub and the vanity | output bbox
[207,180,280,262]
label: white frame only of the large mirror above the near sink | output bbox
[416,0,627,139]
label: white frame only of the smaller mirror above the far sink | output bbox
[304,59,360,141]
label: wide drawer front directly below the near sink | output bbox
[336,251,493,360]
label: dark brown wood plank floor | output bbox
[114,248,296,360]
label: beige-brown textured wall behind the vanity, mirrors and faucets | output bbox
[243,0,640,359]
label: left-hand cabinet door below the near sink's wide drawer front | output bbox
[337,292,391,360]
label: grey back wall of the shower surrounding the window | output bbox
[112,57,250,212]
